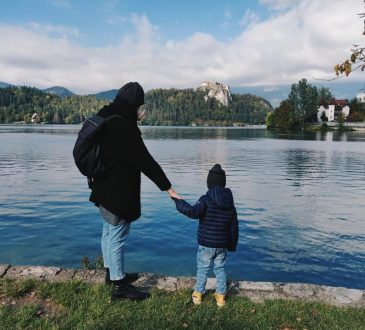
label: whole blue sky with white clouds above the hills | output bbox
[0,0,365,94]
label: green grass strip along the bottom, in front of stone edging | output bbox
[0,279,365,330]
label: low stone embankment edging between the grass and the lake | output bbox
[0,264,365,308]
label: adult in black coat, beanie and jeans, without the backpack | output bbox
[90,82,177,300]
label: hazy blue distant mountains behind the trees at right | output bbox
[231,78,365,107]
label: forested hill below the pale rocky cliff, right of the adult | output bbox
[143,89,273,126]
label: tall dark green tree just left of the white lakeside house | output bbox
[288,78,319,130]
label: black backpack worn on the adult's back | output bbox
[73,115,121,188]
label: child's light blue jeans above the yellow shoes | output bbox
[194,245,227,294]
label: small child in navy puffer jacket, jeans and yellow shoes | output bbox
[173,164,238,307]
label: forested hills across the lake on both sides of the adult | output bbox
[0,86,273,126]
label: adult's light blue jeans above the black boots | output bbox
[99,205,130,281]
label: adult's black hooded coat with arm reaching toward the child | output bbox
[90,103,171,222]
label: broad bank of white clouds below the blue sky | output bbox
[0,0,364,93]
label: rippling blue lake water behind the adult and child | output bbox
[0,125,365,289]
